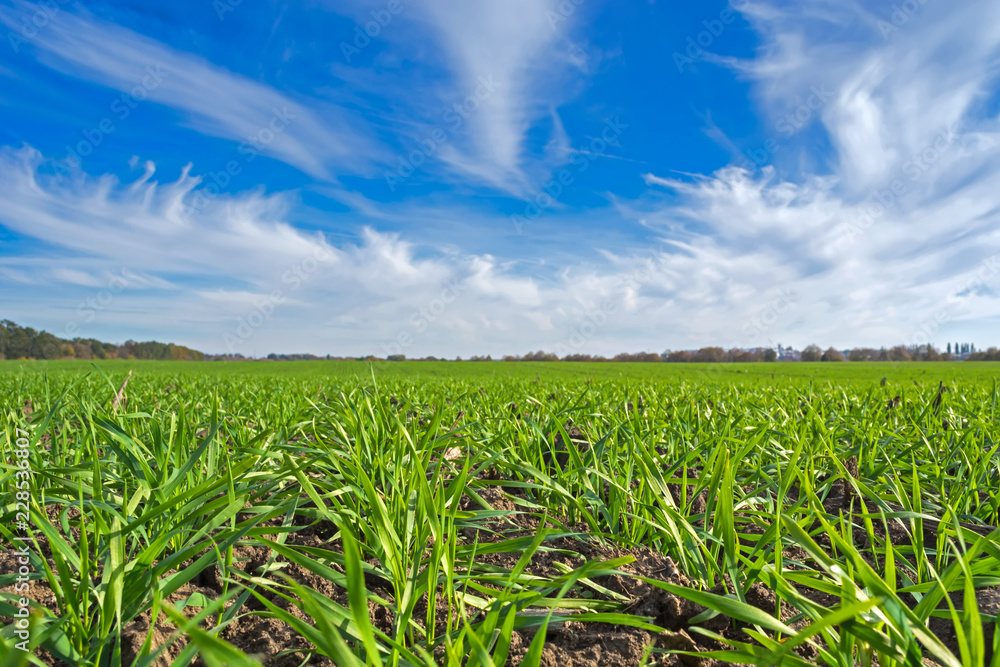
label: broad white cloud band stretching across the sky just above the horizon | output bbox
[0,134,1000,356]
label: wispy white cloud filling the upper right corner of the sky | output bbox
[720,0,1000,196]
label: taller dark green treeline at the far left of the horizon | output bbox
[0,320,205,361]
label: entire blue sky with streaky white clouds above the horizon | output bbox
[0,0,1000,357]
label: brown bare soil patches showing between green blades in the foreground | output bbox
[0,472,1000,667]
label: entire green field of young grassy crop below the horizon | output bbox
[0,361,1000,667]
